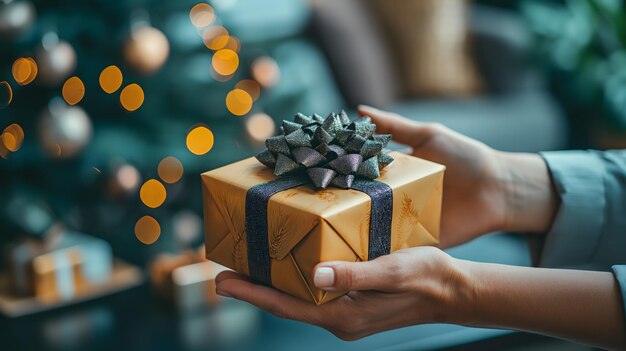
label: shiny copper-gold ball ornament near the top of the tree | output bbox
[124,25,170,75]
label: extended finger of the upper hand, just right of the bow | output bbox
[358,105,433,147]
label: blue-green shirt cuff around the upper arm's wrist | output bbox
[539,151,606,267]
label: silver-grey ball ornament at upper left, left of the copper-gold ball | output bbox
[35,32,76,86]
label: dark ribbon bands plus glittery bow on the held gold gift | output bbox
[246,111,393,286]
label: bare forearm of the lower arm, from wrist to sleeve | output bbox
[451,260,626,349]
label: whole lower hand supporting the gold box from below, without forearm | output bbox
[216,247,471,340]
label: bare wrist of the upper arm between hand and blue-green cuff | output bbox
[496,152,559,233]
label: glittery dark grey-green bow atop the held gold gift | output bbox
[256,111,393,189]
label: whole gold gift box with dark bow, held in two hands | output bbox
[202,113,445,304]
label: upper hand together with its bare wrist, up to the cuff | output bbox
[359,106,557,248]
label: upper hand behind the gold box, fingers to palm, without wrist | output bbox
[359,106,506,248]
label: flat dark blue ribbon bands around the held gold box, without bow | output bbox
[246,177,393,286]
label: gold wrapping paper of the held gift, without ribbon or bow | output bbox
[202,152,445,304]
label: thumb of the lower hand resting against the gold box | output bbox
[313,259,398,291]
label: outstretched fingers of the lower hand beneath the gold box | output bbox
[215,272,319,324]
